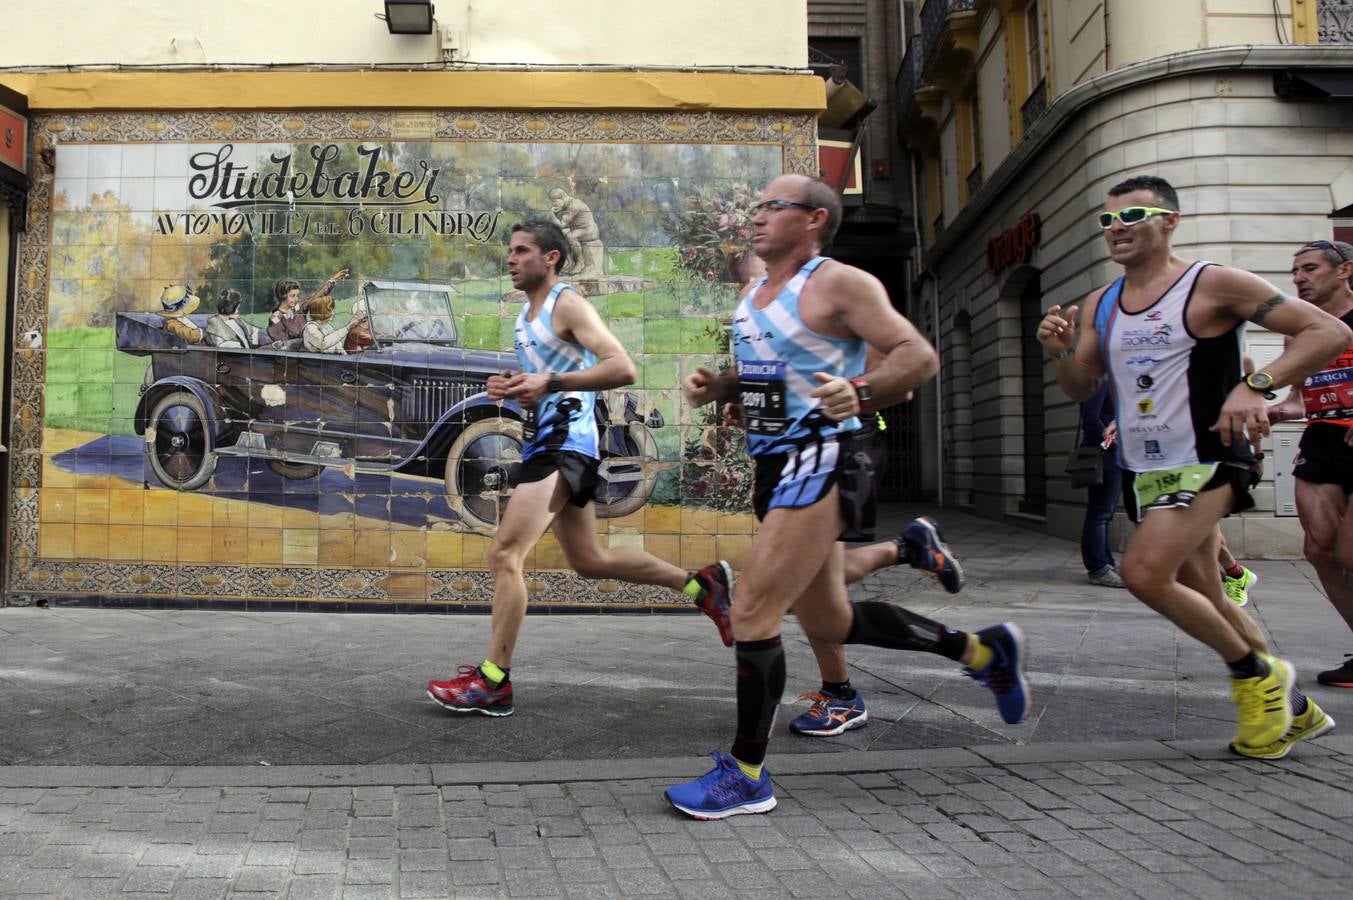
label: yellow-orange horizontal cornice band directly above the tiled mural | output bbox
[0,69,827,115]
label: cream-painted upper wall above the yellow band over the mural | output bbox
[4,0,808,69]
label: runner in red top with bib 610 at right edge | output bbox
[1269,241,1353,688]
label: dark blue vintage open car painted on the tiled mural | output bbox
[116,280,668,533]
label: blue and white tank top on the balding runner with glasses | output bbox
[732,256,867,456]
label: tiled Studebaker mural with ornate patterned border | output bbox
[7,112,816,609]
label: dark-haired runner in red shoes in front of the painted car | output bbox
[428,219,732,716]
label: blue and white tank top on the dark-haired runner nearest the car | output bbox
[513,283,601,459]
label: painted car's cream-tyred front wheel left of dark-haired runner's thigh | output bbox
[446,418,522,533]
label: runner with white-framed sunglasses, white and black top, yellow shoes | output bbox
[1038,176,1353,759]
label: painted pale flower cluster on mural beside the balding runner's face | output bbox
[672,183,756,282]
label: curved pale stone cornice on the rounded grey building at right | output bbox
[921,43,1353,269]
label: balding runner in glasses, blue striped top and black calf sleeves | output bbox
[667,175,1028,819]
